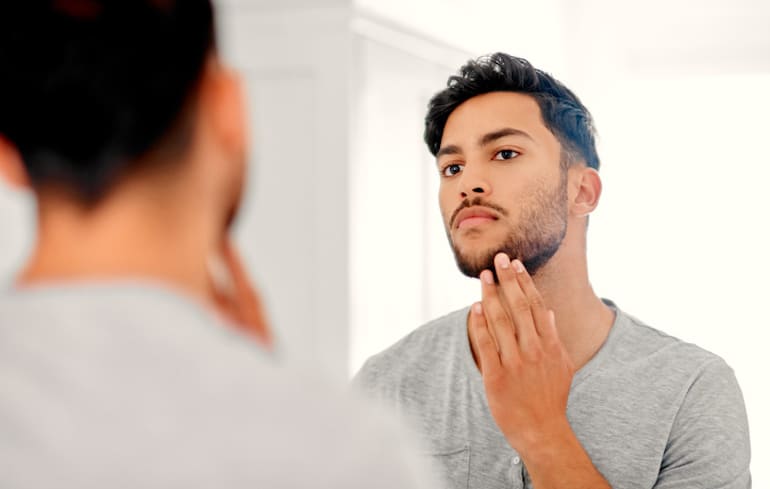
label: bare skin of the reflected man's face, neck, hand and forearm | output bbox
[437,92,614,489]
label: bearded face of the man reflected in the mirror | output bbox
[437,92,567,277]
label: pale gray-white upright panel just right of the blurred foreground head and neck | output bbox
[214,0,352,380]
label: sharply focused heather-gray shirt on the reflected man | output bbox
[354,301,751,489]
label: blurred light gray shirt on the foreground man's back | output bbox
[0,283,433,489]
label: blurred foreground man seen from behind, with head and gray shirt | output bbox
[0,0,430,488]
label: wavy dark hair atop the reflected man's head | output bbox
[424,53,599,169]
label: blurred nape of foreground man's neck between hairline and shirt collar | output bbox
[17,185,213,300]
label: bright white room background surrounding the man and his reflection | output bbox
[0,0,770,487]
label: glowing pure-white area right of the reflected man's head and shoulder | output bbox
[589,73,770,487]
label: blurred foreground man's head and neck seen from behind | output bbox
[0,0,264,336]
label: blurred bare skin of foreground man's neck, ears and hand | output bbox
[0,55,271,345]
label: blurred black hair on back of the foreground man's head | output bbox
[0,0,215,203]
